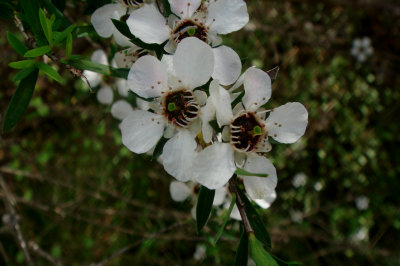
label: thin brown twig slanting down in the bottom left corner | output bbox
[0,175,34,266]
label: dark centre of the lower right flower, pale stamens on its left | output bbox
[230,113,265,152]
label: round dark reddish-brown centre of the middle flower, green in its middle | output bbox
[164,90,200,128]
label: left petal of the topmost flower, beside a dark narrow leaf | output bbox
[126,5,171,44]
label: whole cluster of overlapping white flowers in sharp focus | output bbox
[92,0,308,220]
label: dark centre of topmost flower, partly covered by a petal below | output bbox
[172,19,207,44]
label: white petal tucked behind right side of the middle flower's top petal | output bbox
[212,46,242,85]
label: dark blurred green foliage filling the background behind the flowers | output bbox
[0,0,400,265]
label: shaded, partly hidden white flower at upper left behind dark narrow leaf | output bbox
[90,0,147,46]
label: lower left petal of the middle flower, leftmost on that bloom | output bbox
[120,110,165,153]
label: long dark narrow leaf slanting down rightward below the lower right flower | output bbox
[237,187,271,249]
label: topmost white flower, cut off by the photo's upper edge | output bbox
[127,0,249,53]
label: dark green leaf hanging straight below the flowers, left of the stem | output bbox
[196,186,215,232]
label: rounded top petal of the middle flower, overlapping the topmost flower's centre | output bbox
[173,37,214,89]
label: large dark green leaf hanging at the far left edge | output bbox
[3,69,39,132]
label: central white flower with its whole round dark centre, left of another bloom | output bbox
[120,38,214,181]
